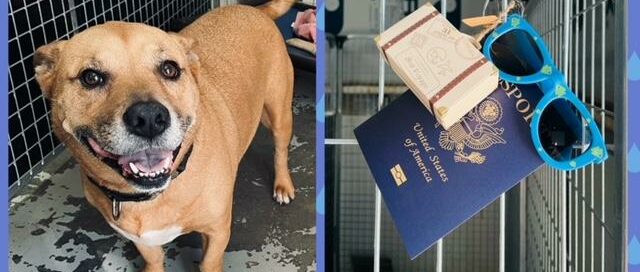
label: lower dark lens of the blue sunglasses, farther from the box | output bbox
[539,99,591,161]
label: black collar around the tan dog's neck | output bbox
[87,147,193,220]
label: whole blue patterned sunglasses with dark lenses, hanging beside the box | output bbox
[483,15,608,170]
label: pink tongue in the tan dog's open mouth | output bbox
[118,150,173,173]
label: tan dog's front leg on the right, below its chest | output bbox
[200,228,231,272]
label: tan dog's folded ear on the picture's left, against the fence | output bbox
[33,40,66,97]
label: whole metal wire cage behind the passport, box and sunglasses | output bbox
[326,0,626,272]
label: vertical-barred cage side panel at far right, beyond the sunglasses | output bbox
[525,0,626,272]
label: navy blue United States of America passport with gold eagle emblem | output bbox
[355,82,543,259]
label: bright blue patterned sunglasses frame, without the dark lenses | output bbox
[482,14,608,171]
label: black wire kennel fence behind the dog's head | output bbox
[8,0,212,186]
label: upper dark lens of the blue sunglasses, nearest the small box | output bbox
[490,29,544,76]
